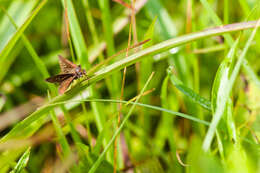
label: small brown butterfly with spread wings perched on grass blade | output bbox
[46,55,86,94]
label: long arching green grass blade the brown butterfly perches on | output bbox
[0,21,256,141]
